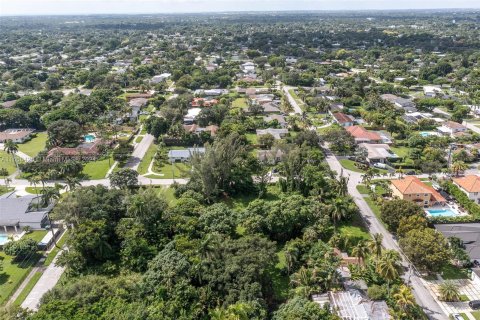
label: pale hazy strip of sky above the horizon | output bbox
[0,0,480,15]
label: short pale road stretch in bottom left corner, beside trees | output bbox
[22,252,65,311]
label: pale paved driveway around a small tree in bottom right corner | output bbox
[423,279,480,319]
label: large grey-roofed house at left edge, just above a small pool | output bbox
[0,193,53,233]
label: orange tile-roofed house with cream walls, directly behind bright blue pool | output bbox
[391,176,446,207]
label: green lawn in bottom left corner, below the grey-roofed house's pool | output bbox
[0,252,40,305]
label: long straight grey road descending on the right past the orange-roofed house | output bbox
[326,151,448,320]
